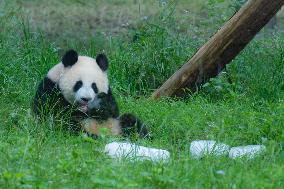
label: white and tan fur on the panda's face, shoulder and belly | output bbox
[44,56,121,135]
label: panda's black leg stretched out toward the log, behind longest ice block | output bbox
[119,113,149,138]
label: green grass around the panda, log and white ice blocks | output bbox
[0,0,284,188]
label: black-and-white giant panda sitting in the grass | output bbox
[32,50,149,138]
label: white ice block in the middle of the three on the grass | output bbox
[190,140,230,158]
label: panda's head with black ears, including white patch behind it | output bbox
[47,50,109,112]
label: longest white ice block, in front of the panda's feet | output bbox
[105,142,170,162]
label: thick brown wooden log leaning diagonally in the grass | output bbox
[152,0,284,99]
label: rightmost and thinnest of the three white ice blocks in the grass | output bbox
[229,145,266,159]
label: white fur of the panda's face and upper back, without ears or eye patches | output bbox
[47,56,109,110]
